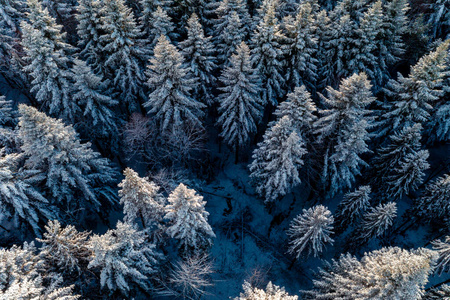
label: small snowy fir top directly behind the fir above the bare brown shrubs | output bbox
[144,6,178,49]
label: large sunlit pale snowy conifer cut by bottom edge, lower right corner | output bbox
[304,247,436,300]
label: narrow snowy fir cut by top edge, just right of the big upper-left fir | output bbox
[76,0,106,74]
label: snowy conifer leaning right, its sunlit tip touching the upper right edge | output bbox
[378,41,450,136]
